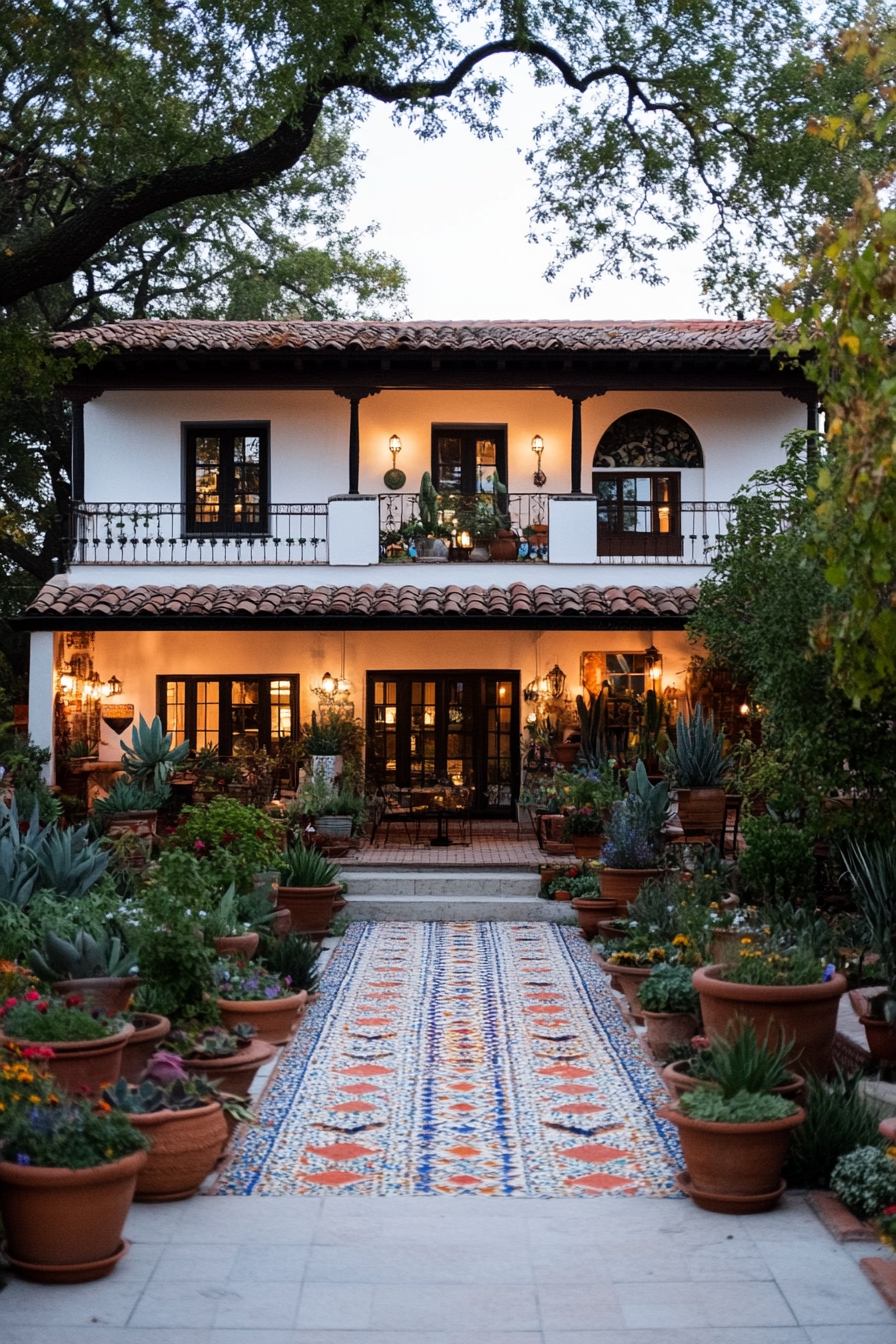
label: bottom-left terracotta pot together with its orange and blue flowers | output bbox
[0,1043,148,1284]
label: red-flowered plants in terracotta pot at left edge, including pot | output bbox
[0,989,134,1094]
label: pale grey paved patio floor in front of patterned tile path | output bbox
[0,1193,896,1344]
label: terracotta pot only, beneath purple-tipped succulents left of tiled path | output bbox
[128,1101,227,1204]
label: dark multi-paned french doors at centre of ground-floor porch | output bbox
[367,672,520,816]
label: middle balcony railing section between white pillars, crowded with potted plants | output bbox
[380,493,548,563]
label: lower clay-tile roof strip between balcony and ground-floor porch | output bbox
[16,575,697,630]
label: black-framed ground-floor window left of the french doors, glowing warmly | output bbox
[156,673,300,757]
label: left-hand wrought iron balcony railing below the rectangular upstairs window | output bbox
[69,504,328,564]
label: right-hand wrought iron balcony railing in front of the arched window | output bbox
[596,500,732,564]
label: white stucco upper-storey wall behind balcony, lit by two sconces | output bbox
[85,390,805,503]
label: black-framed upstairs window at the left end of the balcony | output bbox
[184,421,270,534]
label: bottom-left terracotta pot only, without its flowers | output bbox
[0,1152,146,1284]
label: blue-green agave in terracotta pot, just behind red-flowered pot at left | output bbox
[28,929,140,1015]
